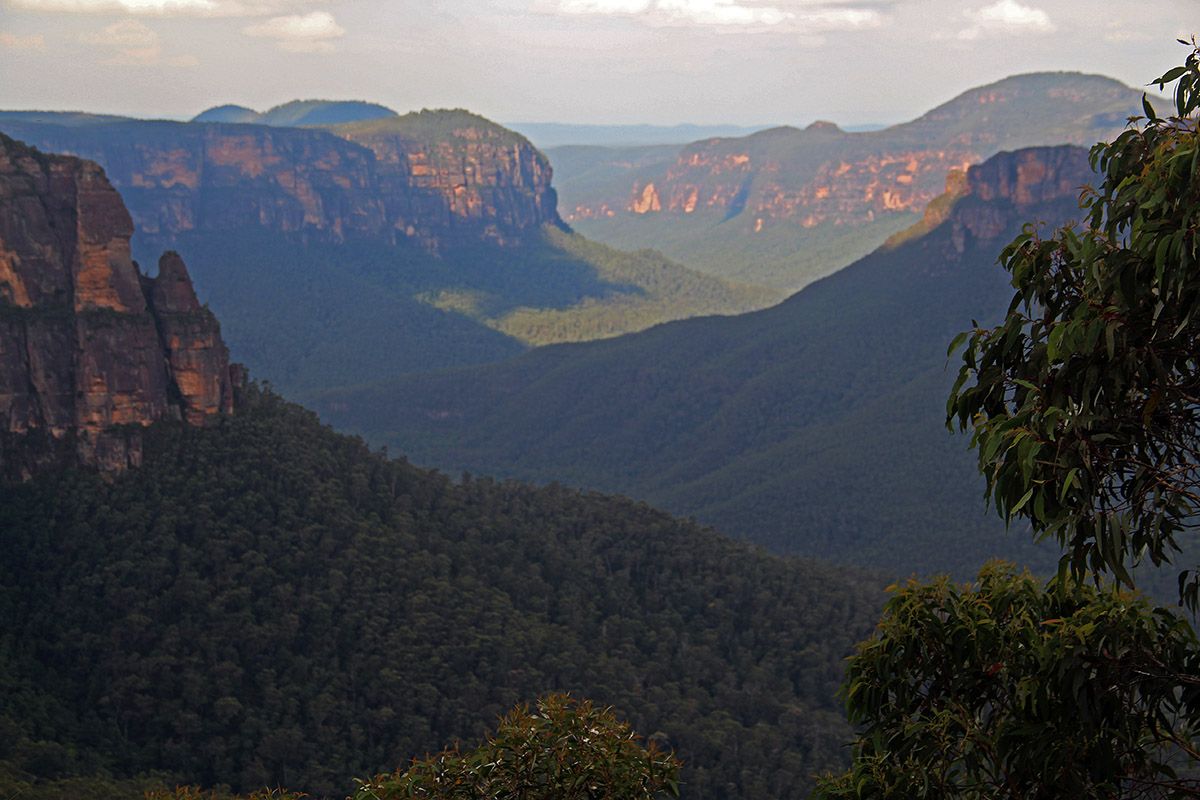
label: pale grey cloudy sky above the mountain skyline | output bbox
[0,0,1200,125]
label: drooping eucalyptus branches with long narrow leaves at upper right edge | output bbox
[947,40,1200,607]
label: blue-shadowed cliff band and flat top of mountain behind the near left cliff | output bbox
[0,112,560,251]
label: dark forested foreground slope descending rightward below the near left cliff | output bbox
[0,391,883,798]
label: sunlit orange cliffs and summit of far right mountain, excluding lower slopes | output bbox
[564,73,1140,233]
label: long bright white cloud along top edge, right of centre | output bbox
[553,0,882,34]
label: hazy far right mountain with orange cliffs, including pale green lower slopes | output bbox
[548,72,1142,290]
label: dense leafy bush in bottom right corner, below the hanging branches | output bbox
[817,564,1200,800]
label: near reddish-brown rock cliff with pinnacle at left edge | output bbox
[0,136,233,477]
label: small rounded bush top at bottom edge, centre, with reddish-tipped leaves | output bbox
[354,694,680,800]
